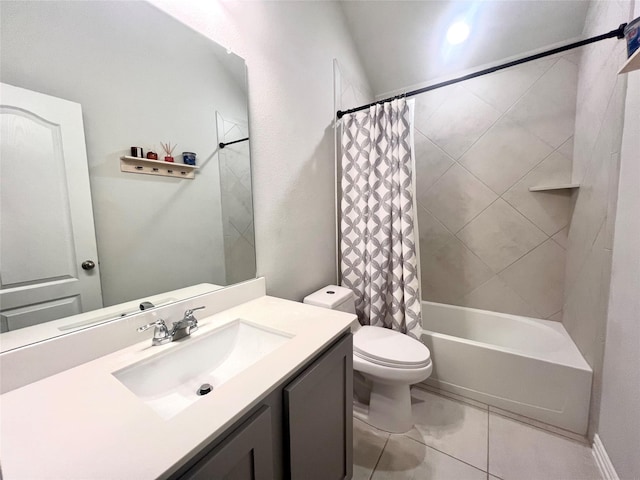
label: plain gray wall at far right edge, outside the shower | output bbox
[598,2,640,480]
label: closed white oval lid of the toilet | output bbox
[353,325,431,368]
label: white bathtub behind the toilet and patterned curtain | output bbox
[422,302,592,435]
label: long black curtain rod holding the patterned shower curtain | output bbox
[337,23,627,118]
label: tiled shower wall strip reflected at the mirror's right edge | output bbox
[216,113,256,285]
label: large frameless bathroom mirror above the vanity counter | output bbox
[0,1,255,351]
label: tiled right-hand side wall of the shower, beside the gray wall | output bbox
[562,1,633,436]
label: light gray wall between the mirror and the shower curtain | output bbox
[153,0,368,300]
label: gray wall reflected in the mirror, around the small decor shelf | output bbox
[0,1,255,342]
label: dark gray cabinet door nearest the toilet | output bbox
[284,333,353,480]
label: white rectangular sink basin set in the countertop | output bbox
[113,319,292,419]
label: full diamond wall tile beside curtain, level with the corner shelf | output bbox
[423,165,497,232]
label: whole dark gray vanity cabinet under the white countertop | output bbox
[171,333,353,480]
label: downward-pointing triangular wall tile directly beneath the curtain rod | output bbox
[463,59,556,113]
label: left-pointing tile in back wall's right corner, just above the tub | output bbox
[500,239,564,317]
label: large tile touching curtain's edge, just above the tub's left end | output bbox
[420,237,493,304]
